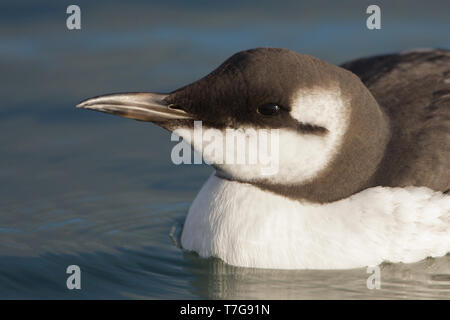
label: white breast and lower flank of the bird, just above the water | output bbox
[181,174,450,269]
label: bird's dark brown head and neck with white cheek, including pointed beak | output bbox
[78,48,389,202]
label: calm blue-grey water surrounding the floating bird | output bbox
[0,1,450,299]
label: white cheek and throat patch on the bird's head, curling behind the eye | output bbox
[172,88,349,185]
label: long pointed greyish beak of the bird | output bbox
[77,92,192,122]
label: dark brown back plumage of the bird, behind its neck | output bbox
[342,50,450,192]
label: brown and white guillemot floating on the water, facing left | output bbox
[77,48,450,269]
